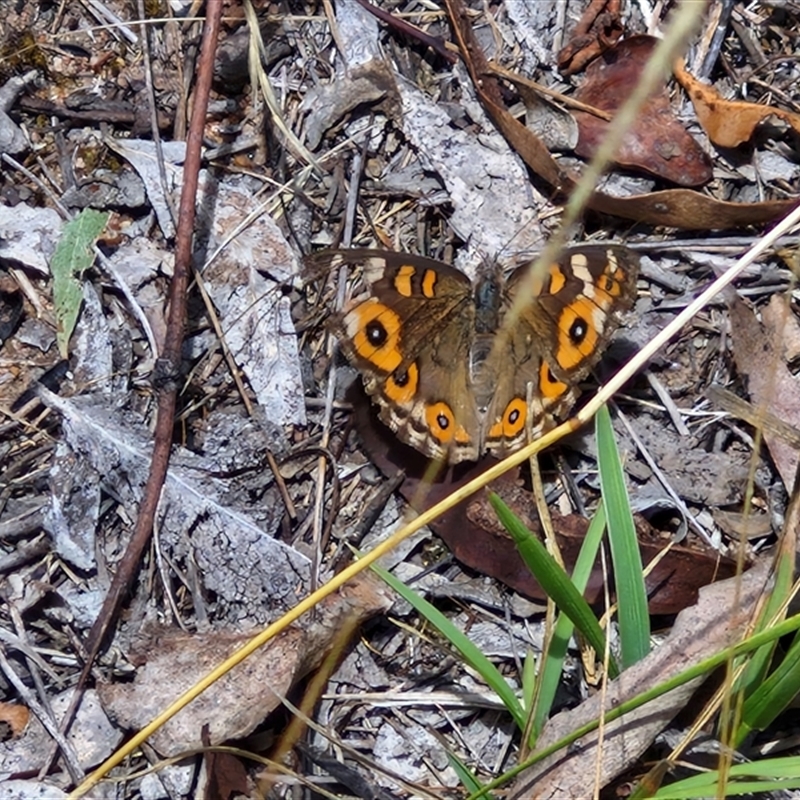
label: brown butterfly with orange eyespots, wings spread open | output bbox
[313,245,638,464]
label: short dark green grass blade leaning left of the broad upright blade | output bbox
[489,493,619,678]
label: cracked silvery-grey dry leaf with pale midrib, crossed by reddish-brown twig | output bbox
[40,388,310,626]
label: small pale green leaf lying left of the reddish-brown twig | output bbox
[50,208,108,358]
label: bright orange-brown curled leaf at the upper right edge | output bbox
[672,60,800,147]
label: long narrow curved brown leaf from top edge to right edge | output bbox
[440,0,798,230]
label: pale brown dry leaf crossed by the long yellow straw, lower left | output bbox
[98,574,391,756]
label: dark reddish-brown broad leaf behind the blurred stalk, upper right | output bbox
[573,36,712,186]
